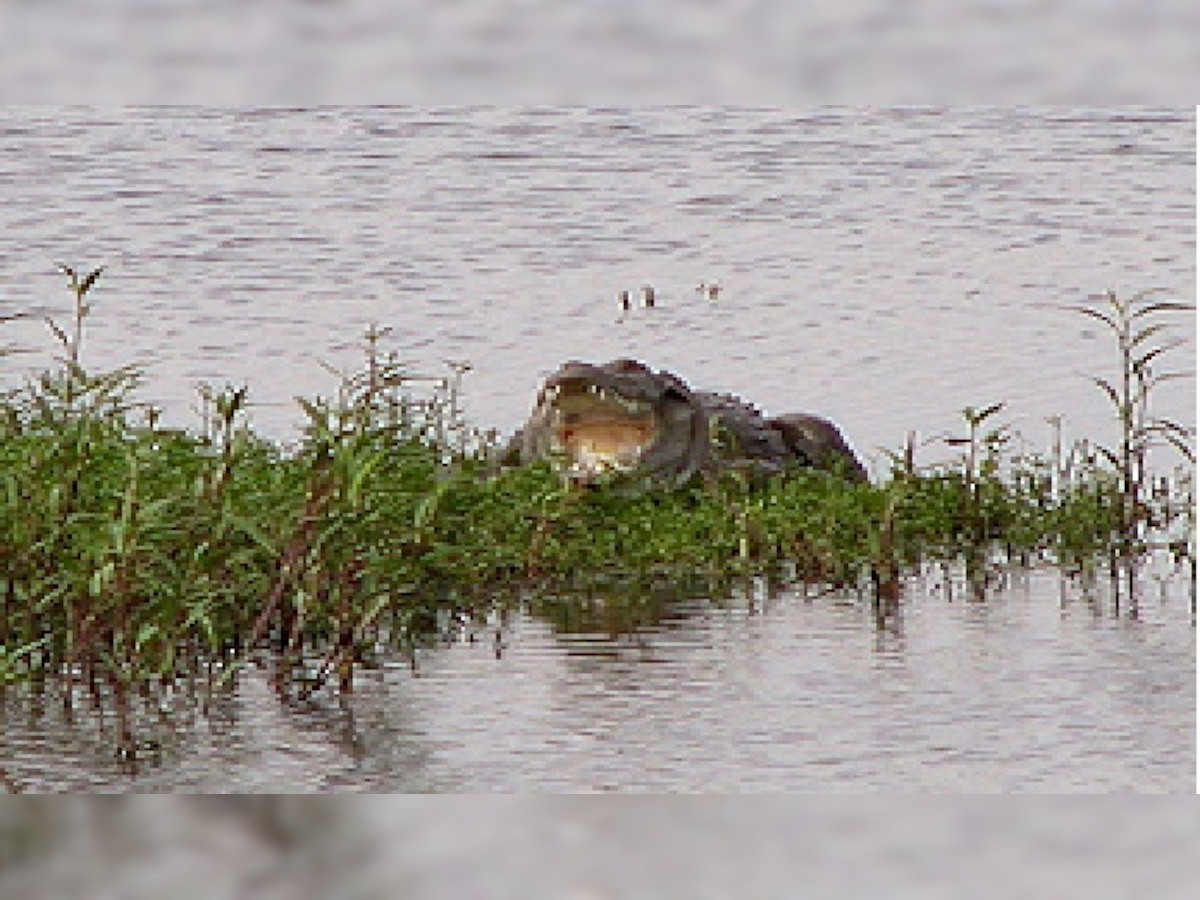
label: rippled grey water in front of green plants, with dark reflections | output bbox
[5,572,1195,792]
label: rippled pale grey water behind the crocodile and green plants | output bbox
[0,109,1195,458]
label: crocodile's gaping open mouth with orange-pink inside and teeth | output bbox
[541,379,659,481]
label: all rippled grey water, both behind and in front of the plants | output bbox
[0,108,1195,791]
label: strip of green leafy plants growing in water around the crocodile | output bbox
[0,268,1196,768]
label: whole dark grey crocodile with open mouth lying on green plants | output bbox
[502,359,868,485]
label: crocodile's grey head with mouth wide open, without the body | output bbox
[504,359,708,482]
